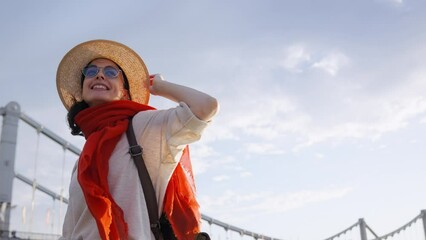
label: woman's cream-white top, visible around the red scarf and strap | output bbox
[60,103,207,240]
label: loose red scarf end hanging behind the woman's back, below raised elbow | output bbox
[163,146,201,240]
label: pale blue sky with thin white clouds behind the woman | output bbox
[0,0,426,240]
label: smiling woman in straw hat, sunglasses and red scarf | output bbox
[56,40,218,239]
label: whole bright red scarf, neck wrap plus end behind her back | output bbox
[75,100,201,240]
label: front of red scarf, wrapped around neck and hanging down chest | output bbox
[75,100,154,240]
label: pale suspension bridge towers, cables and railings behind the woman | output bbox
[0,102,426,240]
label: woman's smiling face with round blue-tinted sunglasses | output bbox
[82,58,129,107]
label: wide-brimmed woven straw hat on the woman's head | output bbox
[56,40,149,110]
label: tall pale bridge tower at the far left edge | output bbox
[0,102,21,239]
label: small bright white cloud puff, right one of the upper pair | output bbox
[312,52,349,76]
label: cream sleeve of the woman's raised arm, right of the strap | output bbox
[133,102,208,211]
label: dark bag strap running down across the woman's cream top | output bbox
[126,118,161,240]
